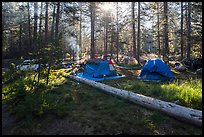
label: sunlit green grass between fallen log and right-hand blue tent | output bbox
[103,78,202,110]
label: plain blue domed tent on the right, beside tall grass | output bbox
[138,58,174,81]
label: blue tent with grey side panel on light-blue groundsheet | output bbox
[77,59,124,81]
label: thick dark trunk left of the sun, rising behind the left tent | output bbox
[90,2,95,59]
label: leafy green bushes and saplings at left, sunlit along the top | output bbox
[2,70,71,125]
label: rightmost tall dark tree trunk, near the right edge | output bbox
[186,2,191,59]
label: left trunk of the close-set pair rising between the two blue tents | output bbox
[132,2,136,58]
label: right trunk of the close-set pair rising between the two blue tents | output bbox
[137,2,140,64]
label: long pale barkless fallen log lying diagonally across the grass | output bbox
[69,75,202,127]
